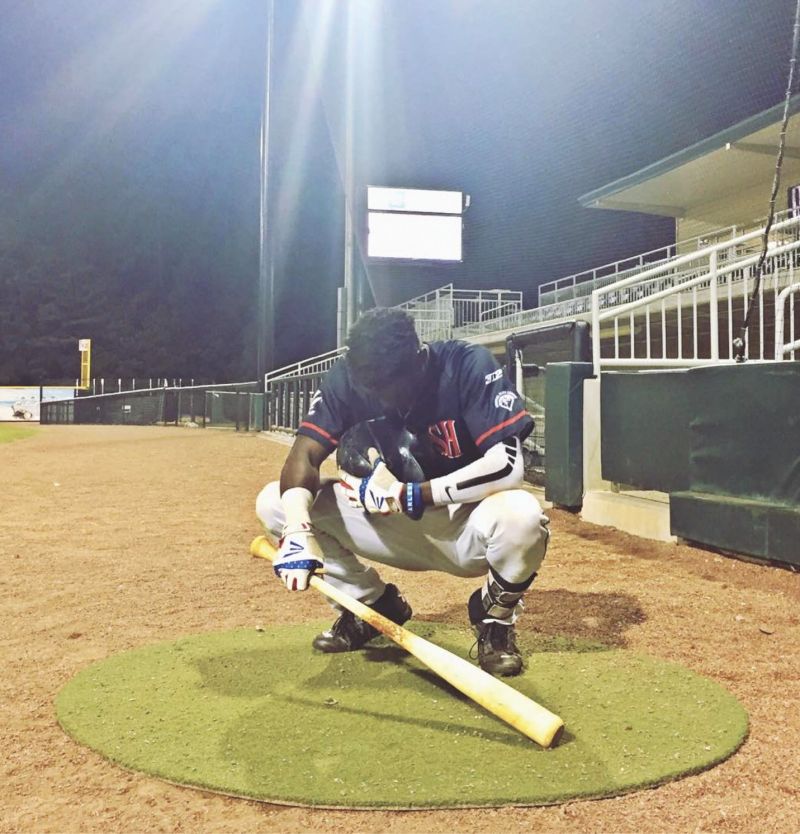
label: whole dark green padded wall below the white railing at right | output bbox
[601,362,800,565]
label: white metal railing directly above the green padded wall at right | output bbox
[591,213,800,373]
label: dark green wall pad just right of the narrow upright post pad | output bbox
[600,370,695,492]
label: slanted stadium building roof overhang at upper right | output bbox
[578,93,800,220]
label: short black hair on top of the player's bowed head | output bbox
[347,307,420,388]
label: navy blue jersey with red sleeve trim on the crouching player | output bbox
[298,341,533,479]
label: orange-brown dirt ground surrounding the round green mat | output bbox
[0,426,800,834]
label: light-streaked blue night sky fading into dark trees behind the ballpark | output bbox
[0,0,795,384]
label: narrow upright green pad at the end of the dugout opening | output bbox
[544,362,592,508]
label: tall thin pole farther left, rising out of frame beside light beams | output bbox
[256,0,275,389]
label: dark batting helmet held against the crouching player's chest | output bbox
[336,417,426,483]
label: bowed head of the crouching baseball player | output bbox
[347,307,427,410]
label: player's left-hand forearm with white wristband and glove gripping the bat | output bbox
[273,435,329,591]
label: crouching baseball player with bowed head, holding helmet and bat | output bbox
[256,308,548,675]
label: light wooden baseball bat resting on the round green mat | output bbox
[250,536,564,747]
